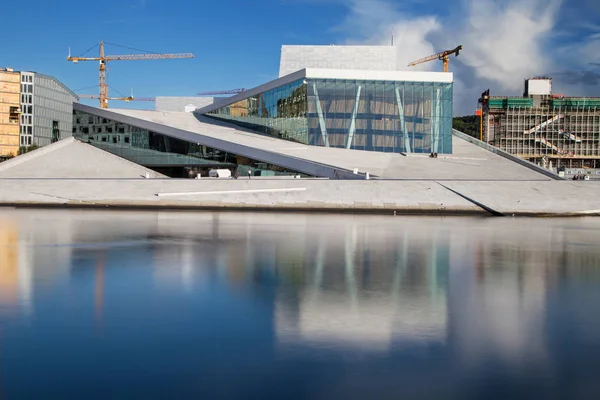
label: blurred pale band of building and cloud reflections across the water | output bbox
[0,210,600,364]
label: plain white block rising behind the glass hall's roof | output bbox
[279,46,398,77]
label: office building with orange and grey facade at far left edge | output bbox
[0,69,79,156]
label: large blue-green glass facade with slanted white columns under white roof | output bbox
[206,78,453,154]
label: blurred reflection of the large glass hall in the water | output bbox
[275,228,449,350]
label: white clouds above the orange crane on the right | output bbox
[328,0,572,115]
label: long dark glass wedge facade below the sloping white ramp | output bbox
[73,110,310,177]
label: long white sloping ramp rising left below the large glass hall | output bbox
[75,104,550,180]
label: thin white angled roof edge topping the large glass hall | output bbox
[194,68,454,114]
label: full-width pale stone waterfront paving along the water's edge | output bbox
[0,179,600,216]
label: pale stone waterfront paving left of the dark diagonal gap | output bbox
[0,179,485,214]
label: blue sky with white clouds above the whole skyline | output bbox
[0,0,600,114]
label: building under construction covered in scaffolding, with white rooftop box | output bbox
[479,78,600,178]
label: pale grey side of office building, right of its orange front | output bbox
[33,73,79,146]
